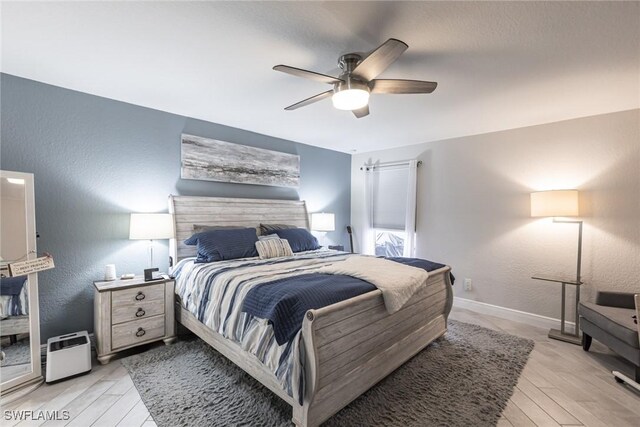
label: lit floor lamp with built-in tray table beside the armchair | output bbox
[531,190,582,345]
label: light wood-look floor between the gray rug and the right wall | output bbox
[451,308,640,427]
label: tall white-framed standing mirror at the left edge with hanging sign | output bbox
[0,171,42,395]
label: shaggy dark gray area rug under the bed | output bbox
[122,321,533,427]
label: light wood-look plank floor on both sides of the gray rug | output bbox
[2,308,640,427]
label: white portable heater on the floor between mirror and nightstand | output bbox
[46,331,91,383]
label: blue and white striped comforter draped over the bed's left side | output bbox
[173,249,351,401]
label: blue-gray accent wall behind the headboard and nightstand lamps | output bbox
[0,74,351,341]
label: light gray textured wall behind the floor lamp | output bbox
[351,110,640,320]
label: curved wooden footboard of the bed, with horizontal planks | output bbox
[293,267,453,426]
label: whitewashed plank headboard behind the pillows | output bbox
[169,195,309,263]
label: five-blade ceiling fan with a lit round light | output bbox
[273,39,438,118]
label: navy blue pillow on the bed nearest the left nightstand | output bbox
[184,228,258,263]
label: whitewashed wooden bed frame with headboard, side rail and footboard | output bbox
[169,196,453,426]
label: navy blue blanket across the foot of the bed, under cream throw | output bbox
[242,258,453,345]
